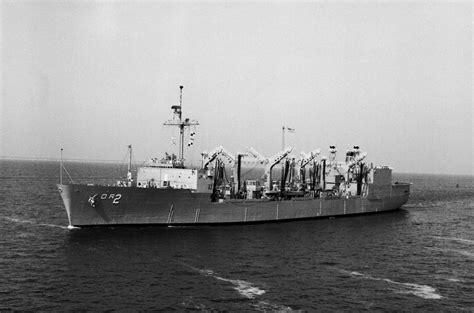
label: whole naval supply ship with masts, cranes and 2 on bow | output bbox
[57,86,410,227]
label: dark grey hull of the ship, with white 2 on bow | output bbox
[58,183,410,227]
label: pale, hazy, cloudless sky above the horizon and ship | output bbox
[0,0,474,175]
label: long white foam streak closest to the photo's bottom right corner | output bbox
[334,267,442,300]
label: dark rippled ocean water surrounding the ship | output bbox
[0,160,474,312]
